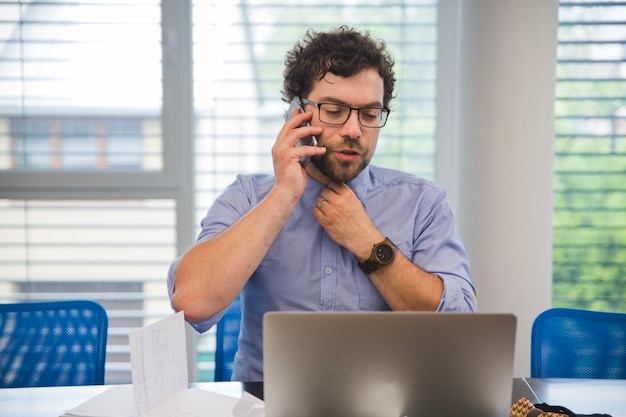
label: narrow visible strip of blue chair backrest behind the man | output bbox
[214,297,241,381]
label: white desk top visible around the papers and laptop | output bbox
[0,378,626,417]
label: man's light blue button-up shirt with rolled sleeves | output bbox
[168,165,476,381]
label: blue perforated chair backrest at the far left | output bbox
[0,300,108,388]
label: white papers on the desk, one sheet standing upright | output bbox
[61,312,258,417]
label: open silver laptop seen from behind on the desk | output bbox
[263,312,517,417]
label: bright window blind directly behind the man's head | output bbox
[193,0,438,211]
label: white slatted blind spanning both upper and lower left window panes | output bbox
[0,0,171,384]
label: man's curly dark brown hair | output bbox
[281,26,396,108]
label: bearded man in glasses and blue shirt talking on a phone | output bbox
[168,27,476,381]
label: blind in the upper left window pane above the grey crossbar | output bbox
[0,0,163,171]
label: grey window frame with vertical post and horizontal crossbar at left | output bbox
[0,0,195,252]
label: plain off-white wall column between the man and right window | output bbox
[438,0,558,376]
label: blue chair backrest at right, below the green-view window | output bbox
[530,308,626,379]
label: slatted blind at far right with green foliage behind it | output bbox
[553,1,626,311]
